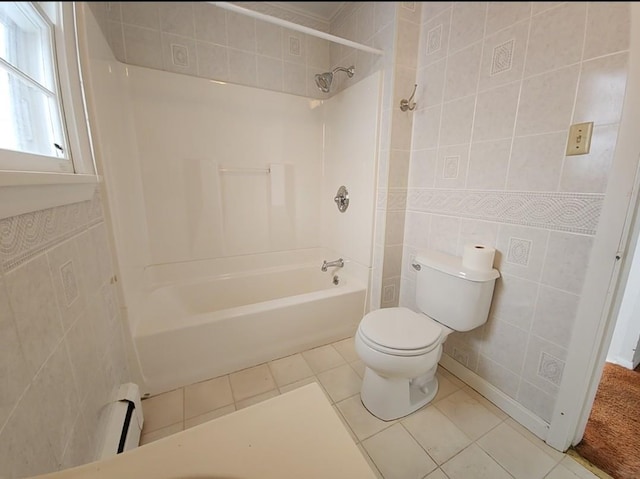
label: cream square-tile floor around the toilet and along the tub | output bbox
[141,338,597,479]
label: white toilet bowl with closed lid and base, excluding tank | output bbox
[355,308,452,421]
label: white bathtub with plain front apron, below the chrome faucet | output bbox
[134,265,366,395]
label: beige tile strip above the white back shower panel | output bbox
[91,2,329,98]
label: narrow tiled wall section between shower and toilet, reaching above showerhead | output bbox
[330,2,421,309]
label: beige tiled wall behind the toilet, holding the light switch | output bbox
[400,2,629,421]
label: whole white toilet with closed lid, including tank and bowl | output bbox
[355,250,500,421]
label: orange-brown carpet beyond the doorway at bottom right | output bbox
[575,363,640,479]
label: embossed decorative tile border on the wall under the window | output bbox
[0,193,103,272]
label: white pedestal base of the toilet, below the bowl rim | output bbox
[360,366,438,421]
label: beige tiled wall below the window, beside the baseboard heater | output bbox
[0,190,130,478]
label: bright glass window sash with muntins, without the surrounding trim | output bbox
[0,2,73,172]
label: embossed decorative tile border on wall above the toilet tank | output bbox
[407,188,604,235]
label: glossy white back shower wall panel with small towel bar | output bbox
[127,66,323,264]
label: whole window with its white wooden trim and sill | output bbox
[0,2,99,218]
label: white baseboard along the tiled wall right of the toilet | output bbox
[440,354,549,441]
